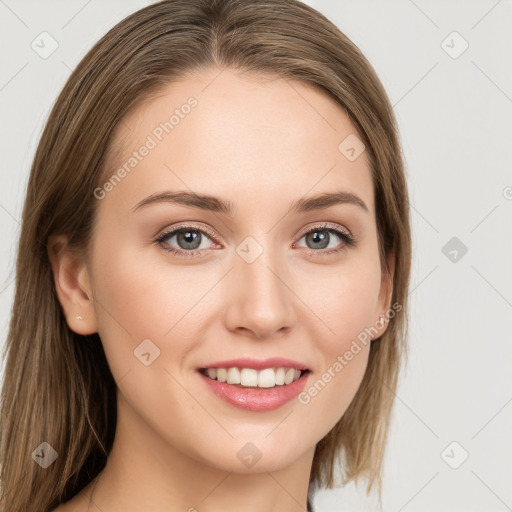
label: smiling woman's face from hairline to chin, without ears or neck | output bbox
[77,69,388,473]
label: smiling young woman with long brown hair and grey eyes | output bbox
[0,0,411,512]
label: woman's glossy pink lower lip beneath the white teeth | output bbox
[198,371,310,411]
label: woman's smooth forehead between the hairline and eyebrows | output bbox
[98,68,374,218]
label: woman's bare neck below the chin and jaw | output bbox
[82,393,314,512]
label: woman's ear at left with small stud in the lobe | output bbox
[48,235,98,336]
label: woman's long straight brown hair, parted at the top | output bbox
[0,0,411,512]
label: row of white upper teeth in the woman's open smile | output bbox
[201,367,301,388]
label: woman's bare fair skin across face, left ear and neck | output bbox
[50,68,393,512]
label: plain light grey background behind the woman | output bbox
[0,0,512,512]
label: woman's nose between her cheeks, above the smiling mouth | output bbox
[223,244,297,340]
